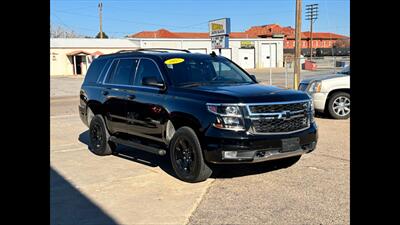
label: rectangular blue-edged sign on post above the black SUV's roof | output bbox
[208,18,231,55]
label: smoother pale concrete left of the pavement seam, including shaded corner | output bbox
[50,98,213,225]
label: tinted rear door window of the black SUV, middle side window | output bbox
[108,59,138,85]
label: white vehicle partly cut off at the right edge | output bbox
[298,66,350,119]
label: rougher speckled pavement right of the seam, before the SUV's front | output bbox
[189,118,350,224]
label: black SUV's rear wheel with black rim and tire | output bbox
[89,115,116,156]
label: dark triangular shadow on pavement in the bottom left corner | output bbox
[50,168,118,225]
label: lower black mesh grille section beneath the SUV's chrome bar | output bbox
[253,116,309,133]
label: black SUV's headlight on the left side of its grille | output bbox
[207,103,244,131]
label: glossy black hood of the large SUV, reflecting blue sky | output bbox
[186,84,310,103]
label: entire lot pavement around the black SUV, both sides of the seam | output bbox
[50,97,350,224]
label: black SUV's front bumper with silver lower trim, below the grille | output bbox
[203,123,318,164]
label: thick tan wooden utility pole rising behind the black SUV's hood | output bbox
[293,0,301,90]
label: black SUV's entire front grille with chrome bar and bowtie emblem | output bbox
[248,101,310,133]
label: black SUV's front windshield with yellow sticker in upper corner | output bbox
[164,57,254,87]
